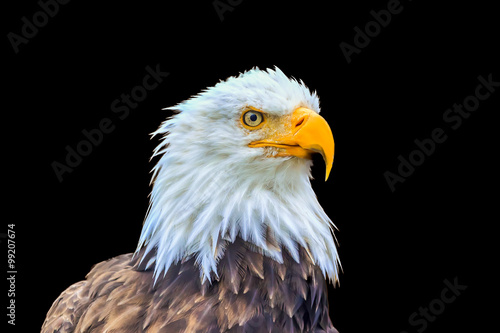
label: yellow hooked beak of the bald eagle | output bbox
[248,107,335,181]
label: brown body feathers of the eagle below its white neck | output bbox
[42,238,337,333]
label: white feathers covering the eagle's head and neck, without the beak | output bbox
[138,68,338,281]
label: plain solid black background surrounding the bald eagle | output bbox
[4,0,500,333]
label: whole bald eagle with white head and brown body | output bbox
[42,68,339,333]
